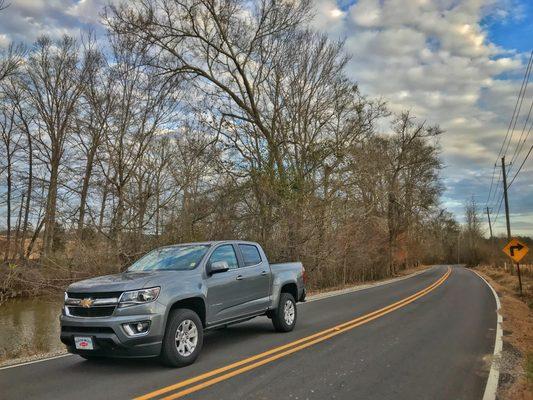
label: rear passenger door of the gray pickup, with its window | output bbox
[237,243,271,313]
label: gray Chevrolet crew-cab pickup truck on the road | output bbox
[60,240,305,366]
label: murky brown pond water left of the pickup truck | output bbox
[0,294,65,360]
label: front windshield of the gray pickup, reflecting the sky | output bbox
[127,245,209,272]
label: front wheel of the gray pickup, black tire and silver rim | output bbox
[160,308,204,367]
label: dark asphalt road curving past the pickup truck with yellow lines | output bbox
[0,266,496,400]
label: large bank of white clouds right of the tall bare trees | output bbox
[317,0,533,234]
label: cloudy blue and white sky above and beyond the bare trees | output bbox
[0,0,533,235]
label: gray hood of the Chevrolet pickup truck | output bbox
[67,271,165,293]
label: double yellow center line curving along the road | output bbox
[135,267,452,400]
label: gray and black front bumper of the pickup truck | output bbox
[60,302,165,358]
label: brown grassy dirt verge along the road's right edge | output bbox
[476,266,533,400]
